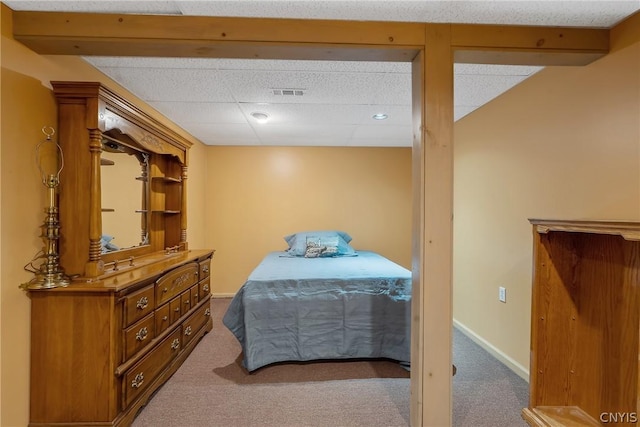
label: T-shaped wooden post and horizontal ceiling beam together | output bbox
[8,8,609,426]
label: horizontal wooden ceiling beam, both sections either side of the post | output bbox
[13,11,609,65]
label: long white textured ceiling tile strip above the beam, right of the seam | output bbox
[179,0,638,27]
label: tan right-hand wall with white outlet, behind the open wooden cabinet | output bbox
[454,38,640,372]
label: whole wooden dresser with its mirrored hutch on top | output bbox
[26,82,214,426]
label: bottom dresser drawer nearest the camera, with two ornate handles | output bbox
[122,328,182,407]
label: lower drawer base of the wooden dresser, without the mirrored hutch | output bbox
[30,250,213,426]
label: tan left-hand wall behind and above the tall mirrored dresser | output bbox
[0,5,205,427]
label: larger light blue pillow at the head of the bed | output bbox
[284,231,357,258]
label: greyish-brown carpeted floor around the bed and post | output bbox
[133,299,528,427]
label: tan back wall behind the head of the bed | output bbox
[205,147,411,294]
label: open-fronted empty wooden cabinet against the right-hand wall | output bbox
[522,220,640,426]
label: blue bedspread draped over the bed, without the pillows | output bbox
[223,251,411,371]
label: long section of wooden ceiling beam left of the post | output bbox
[13,12,424,61]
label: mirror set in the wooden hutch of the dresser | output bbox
[100,136,149,254]
